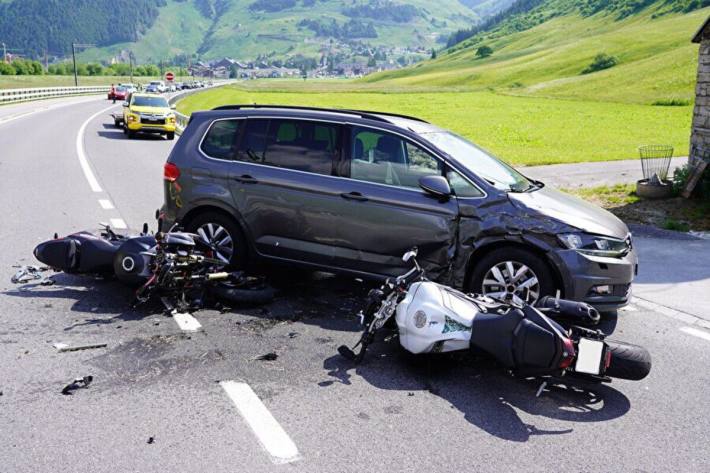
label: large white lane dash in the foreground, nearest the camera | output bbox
[219,381,301,463]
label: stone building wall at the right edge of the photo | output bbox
[689,17,710,163]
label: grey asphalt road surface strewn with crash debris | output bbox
[0,94,710,472]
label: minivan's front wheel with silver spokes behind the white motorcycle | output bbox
[466,247,555,304]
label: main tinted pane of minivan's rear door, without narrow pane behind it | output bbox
[263,119,339,175]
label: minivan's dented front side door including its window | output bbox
[335,126,458,275]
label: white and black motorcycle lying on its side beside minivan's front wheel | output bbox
[338,248,651,382]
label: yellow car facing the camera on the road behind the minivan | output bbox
[123,94,175,140]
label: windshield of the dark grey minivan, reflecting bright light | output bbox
[422,131,535,192]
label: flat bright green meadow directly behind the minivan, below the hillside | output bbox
[178,80,692,165]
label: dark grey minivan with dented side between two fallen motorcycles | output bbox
[160,105,637,310]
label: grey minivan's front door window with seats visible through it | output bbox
[350,127,442,189]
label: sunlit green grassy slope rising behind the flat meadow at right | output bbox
[363,2,710,104]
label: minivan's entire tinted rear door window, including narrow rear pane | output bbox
[238,119,340,175]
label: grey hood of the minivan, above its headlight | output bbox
[508,187,629,239]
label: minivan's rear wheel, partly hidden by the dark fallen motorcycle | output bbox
[186,212,247,269]
